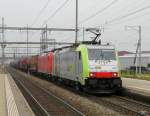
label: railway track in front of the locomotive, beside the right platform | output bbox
[7,67,150,116]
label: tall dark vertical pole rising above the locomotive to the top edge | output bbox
[75,0,78,43]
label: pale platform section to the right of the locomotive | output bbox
[122,78,150,97]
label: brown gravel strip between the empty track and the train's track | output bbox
[11,68,121,116]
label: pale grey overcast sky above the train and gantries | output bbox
[0,0,150,55]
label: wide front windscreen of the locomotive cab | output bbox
[88,49,116,60]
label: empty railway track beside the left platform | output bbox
[9,69,84,116]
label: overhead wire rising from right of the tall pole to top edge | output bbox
[79,0,118,24]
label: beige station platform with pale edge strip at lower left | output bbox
[0,74,35,116]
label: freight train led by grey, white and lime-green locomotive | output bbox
[11,43,122,93]
